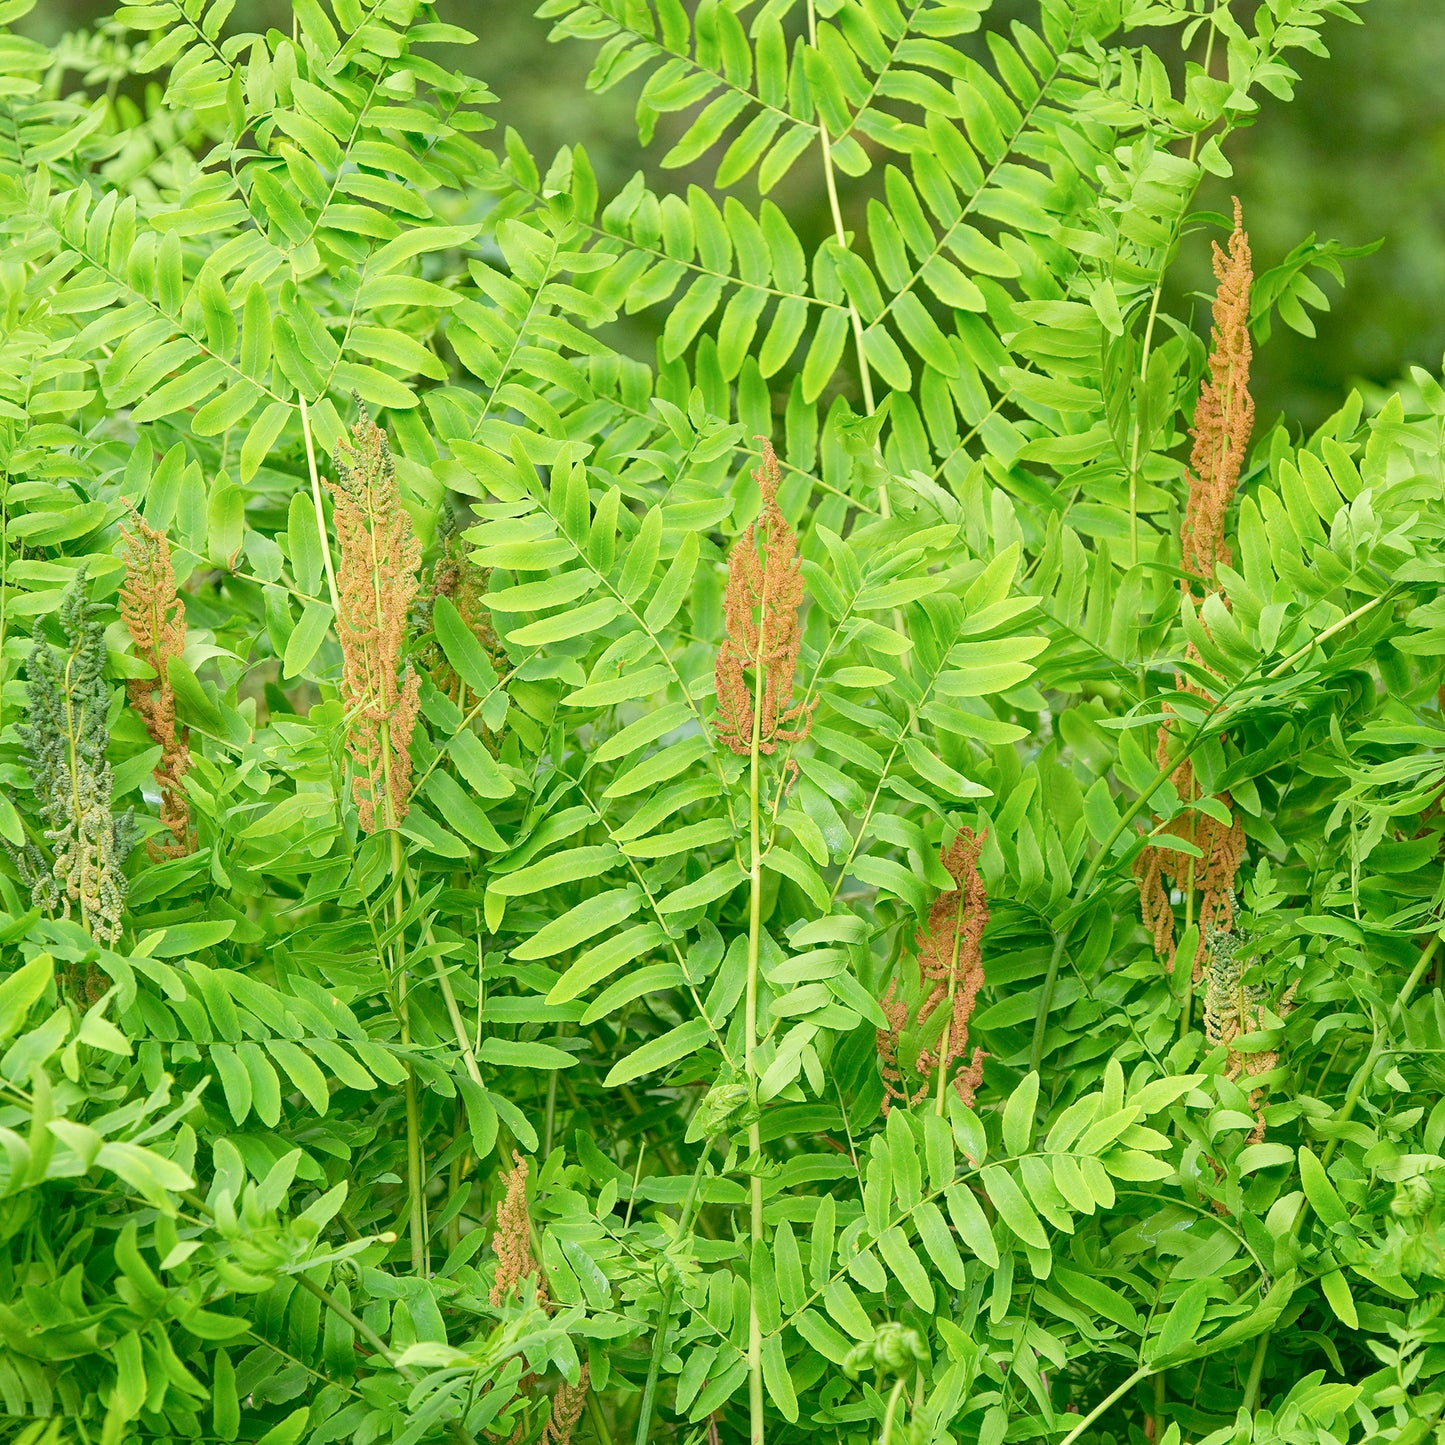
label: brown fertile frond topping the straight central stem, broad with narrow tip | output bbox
[715,439,812,754]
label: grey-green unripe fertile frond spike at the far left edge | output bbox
[7,566,139,944]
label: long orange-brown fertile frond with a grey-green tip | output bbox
[327,400,422,832]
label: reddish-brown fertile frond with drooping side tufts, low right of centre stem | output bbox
[877,828,988,1113]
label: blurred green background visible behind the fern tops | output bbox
[22,0,1445,428]
